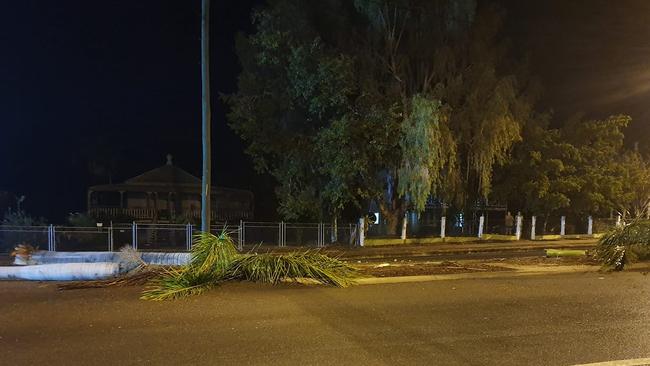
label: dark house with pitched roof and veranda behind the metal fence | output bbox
[88,155,254,223]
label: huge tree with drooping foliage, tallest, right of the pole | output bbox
[227,0,531,229]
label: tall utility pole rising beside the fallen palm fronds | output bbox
[201,0,211,233]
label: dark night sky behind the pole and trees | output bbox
[0,0,650,221]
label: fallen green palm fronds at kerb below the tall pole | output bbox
[142,230,357,301]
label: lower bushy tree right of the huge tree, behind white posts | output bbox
[495,115,636,217]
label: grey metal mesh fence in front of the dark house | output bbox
[0,221,357,252]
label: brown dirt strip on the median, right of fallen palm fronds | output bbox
[357,261,514,277]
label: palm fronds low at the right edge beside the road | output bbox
[596,220,650,271]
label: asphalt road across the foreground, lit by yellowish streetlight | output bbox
[0,272,650,365]
